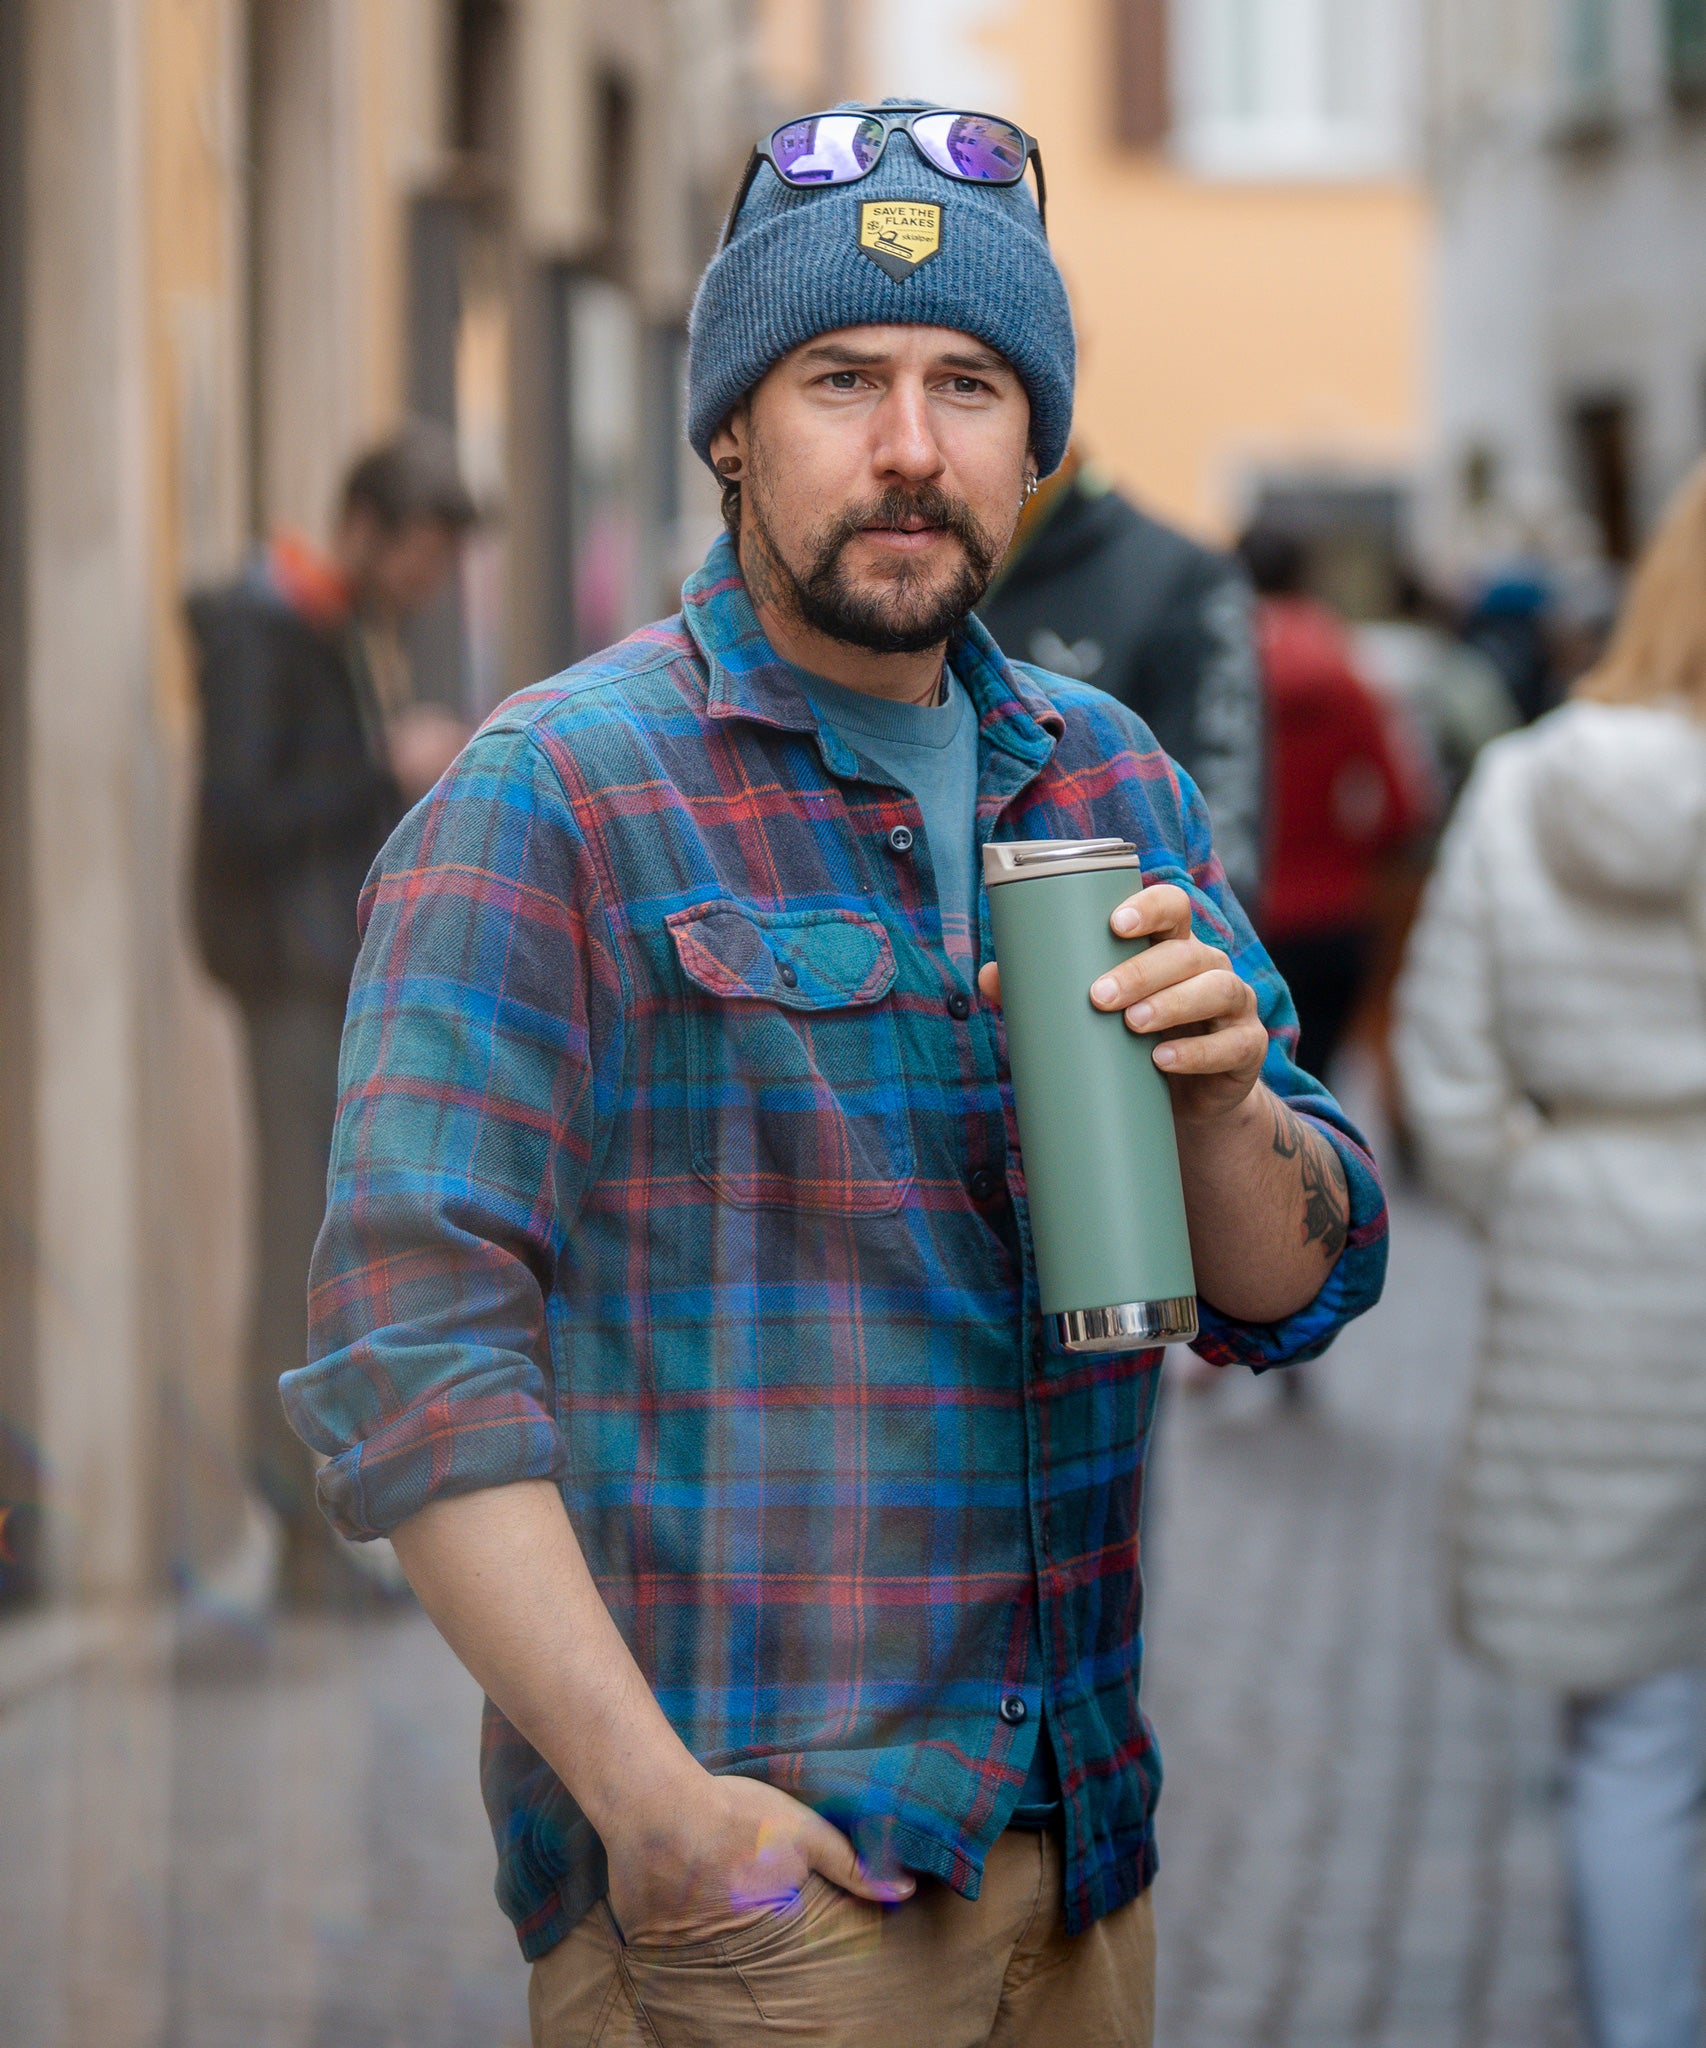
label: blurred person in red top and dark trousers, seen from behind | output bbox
[1239,526,1434,1075]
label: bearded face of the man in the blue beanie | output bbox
[711,326,1034,653]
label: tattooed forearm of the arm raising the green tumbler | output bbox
[1178,1083,1350,1323]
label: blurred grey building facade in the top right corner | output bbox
[1427,0,1706,569]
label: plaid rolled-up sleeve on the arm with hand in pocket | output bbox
[281,727,623,1538]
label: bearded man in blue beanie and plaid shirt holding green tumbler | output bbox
[285,106,1384,2048]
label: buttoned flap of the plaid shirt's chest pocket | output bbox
[664,899,895,1010]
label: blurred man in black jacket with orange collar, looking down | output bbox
[188,424,473,1593]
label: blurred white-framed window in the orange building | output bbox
[1171,0,1409,178]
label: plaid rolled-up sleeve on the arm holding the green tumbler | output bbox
[1145,772,1387,1372]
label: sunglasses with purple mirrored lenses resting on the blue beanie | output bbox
[719,104,1049,248]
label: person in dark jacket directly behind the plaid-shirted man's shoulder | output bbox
[977,455,1266,903]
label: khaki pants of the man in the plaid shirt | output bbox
[528,1829,1155,2048]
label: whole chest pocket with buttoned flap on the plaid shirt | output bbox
[668,901,913,1217]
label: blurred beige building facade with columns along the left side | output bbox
[0,0,756,1606]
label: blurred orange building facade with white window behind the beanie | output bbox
[766,0,1432,602]
